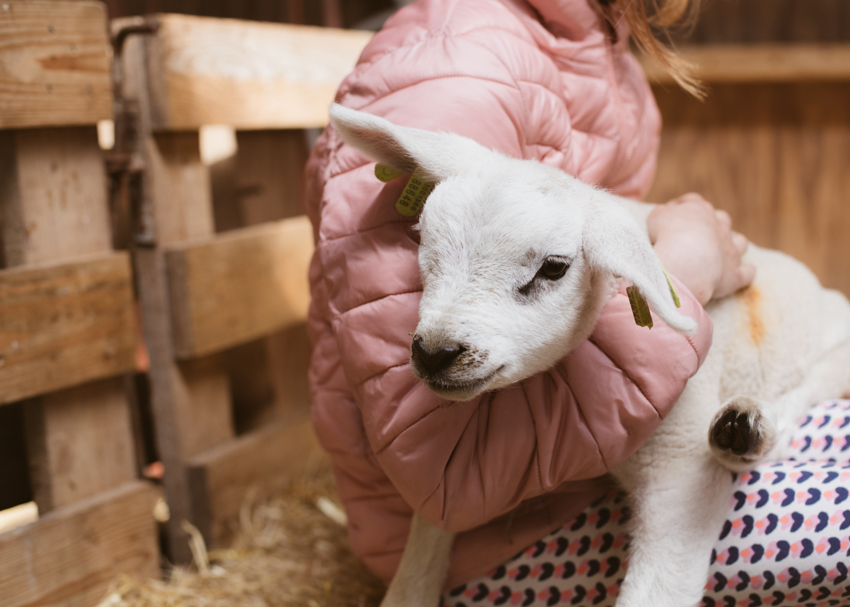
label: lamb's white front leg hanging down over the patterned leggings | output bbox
[617,450,732,607]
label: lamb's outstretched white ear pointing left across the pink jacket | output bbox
[330,103,484,183]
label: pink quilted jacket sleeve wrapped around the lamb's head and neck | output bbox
[312,34,711,531]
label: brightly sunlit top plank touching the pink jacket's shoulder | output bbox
[141,15,372,130]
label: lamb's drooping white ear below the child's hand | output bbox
[583,200,697,334]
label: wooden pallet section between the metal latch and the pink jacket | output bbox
[114,15,370,561]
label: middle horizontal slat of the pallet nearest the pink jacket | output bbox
[167,217,313,358]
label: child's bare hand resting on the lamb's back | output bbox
[646,194,756,305]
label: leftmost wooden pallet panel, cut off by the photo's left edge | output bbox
[0,0,159,607]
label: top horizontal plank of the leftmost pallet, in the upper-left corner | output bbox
[0,0,112,128]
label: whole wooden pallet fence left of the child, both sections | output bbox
[0,0,369,607]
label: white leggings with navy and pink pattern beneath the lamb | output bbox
[443,400,850,607]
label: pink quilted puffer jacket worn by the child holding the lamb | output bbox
[308,0,711,585]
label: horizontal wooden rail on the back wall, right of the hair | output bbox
[643,44,850,84]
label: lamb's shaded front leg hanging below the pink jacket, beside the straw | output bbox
[381,514,454,607]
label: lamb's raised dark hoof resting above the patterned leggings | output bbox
[708,396,776,472]
